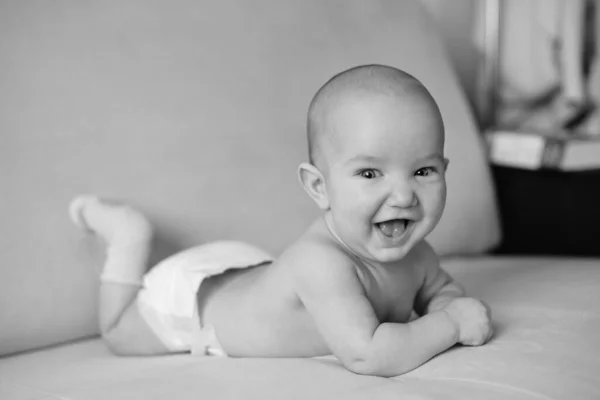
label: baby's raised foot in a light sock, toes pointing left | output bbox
[69,195,153,246]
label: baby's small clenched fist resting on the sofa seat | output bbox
[444,297,493,346]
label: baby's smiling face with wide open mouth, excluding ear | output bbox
[323,93,447,263]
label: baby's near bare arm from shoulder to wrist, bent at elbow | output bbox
[293,244,458,376]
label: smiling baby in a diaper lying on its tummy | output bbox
[70,65,492,376]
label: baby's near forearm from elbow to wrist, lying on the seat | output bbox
[353,311,458,376]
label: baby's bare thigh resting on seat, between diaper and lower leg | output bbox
[102,301,172,356]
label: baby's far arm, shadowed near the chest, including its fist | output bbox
[414,242,493,346]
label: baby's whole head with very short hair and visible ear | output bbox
[299,65,447,262]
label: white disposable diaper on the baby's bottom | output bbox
[137,241,273,355]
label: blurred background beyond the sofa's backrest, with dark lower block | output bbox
[423,0,600,256]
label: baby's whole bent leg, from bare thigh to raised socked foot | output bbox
[69,196,169,355]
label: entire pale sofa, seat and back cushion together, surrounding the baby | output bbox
[0,0,600,400]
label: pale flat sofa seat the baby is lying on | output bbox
[0,258,600,400]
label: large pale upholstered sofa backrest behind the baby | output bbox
[0,0,498,354]
